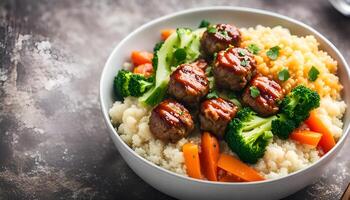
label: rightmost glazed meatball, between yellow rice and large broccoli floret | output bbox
[242,76,283,116]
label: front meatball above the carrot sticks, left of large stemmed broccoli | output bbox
[199,98,238,138]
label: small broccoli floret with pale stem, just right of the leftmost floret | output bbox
[129,74,153,97]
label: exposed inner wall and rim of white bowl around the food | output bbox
[100,7,350,184]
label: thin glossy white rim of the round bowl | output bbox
[99,6,350,186]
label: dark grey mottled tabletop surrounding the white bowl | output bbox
[0,0,350,200]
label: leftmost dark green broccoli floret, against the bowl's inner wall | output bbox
[114,69,133,99]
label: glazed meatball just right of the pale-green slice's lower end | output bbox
[168,63,209,106]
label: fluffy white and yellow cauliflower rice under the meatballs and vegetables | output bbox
[109,26,346,178]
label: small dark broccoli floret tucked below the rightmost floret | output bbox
[271,114,298,139]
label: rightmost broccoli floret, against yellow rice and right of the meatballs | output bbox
[280,85,320,122]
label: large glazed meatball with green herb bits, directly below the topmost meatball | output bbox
[213,47,256,91]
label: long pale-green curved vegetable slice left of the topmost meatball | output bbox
[139,28,205,106]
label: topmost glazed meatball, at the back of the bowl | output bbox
[201,24,241,57]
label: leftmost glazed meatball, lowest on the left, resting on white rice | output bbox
[149,99,194,143]
